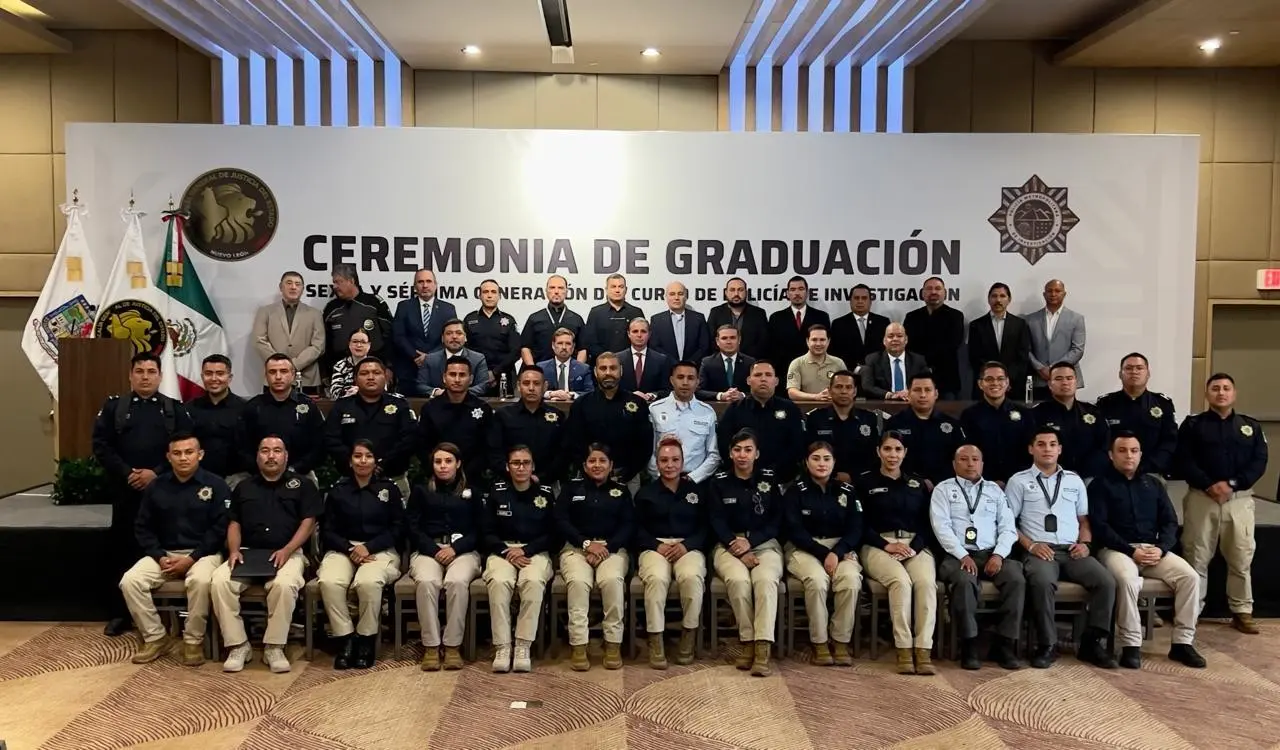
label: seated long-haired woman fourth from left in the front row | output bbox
[408,443,484,672]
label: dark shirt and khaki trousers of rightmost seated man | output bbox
[1089,467,1201,648]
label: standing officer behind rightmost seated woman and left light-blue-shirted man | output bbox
[884,370,965,481]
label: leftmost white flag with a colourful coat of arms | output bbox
[22,198,102,398]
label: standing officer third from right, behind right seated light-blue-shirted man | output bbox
[1032,362,1111,480]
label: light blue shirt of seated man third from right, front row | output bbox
[929,476,1018,559]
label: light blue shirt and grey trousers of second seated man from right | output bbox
[1005,463,1116,651]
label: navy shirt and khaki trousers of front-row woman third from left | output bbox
[316,477,404,642]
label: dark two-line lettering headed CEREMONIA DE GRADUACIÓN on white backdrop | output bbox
[302,229,960,302]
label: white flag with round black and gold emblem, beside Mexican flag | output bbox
[93,209,182,399]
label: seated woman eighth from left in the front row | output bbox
[708,430,782,677]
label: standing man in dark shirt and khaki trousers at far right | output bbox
[1178,372,1267,635]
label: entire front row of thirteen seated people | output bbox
[120,427,1204,676]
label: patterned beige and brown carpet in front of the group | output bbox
[0,621,1280,750]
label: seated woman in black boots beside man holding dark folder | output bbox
[316,438,404,669]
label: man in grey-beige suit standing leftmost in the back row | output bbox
[251,271,324,394]
